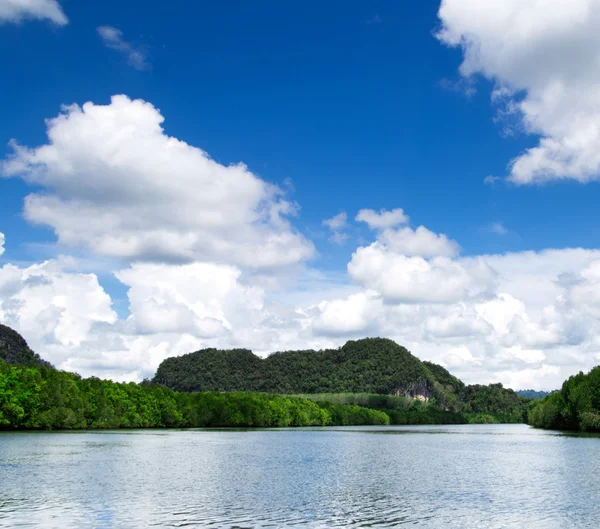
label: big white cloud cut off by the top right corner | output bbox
[438,0,600,184]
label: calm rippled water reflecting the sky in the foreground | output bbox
[0,425,600,529]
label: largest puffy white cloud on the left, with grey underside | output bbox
[2,96,314,268]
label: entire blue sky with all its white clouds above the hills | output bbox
[0,0,600,389]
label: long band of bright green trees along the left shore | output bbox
[0,360,390,430]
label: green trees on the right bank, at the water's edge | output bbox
[528,366,600,432]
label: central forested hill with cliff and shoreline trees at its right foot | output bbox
[154,338,525,424]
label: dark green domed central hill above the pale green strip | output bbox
[154,338,435,398]
